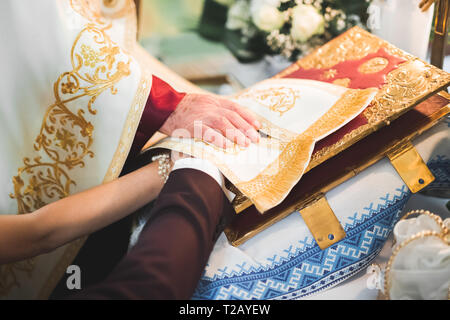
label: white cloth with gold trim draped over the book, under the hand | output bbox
[153,79,378,212]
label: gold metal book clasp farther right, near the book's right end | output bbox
[386,141,434,193]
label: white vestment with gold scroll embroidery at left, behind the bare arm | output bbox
[0,0,152,299]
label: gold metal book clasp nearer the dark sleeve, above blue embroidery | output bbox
[299,195,346,250]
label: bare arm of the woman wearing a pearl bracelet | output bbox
[0,163,163,263]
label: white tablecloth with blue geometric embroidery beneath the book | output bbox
[193,118,450,300]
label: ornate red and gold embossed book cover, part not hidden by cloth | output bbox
[229,27,450,213]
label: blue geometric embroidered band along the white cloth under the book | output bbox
[193,156,450,300]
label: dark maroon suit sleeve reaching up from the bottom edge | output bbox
[69,169,235,299]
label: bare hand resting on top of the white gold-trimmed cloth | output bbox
[160,94,261,148]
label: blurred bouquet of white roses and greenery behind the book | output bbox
[204,0,370,61]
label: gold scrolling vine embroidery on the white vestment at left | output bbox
[0,24,131,295]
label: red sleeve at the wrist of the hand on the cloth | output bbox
[129,76,186,157]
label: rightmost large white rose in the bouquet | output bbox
[291,4,325,42]
